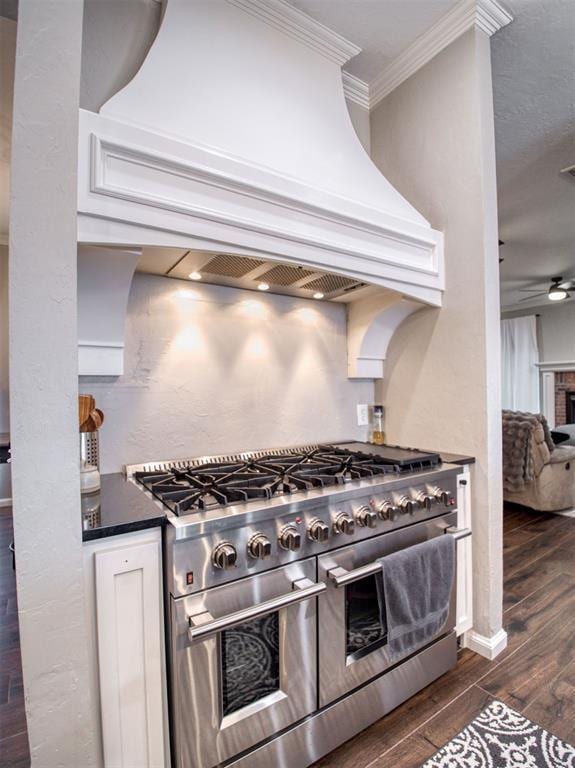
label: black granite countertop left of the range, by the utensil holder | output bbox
[82,473,166,541]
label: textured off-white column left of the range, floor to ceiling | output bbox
[10,0,96,768]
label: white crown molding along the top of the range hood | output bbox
[228,0,361,67]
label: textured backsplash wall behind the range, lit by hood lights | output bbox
[81,274,373,472]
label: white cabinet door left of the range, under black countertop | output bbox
[94,535,167,768]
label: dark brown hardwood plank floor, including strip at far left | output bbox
[0,508,575,768]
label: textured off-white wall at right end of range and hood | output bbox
[371,31,502,638]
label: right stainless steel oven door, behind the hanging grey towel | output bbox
[318,512,457,707]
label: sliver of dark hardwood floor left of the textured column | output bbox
[0,507,30,768]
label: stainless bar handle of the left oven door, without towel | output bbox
[188,579,327,643]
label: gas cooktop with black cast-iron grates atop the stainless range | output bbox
[132,443,440,515]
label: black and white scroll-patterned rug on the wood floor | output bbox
[422,701,575,768]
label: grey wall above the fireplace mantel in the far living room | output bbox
[502,301,575,363]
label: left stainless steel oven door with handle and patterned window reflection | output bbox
[171,558,326,768]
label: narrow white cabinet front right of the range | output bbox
[455,466,473,636]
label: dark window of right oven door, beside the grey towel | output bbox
[345,574,387,660]
